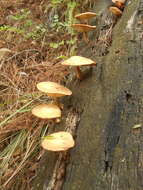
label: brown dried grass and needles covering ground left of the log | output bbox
[0,0,70,190]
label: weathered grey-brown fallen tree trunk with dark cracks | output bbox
[35,0,143,190]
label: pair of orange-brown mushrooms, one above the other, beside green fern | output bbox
[71,12,97,42]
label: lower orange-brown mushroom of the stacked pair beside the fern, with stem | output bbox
[71,24,96,42]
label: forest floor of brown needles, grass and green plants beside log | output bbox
[0,0,86,190]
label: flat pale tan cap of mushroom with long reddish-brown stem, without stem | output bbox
[61,56,96,66]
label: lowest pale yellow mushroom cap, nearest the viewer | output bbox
[41,131,75,151]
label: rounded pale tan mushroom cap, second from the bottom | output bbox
[32,104,61,119]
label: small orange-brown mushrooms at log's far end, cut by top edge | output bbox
[109,0,126,16]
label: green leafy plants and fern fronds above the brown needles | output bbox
[0,0,77,45]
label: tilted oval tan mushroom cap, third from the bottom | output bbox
[37,81,72,97]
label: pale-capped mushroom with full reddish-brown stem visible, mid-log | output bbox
[61,56,96,79]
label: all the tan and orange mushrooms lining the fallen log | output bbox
[32,4,126,151]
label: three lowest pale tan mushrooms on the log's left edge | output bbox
[32,81,75,151]
